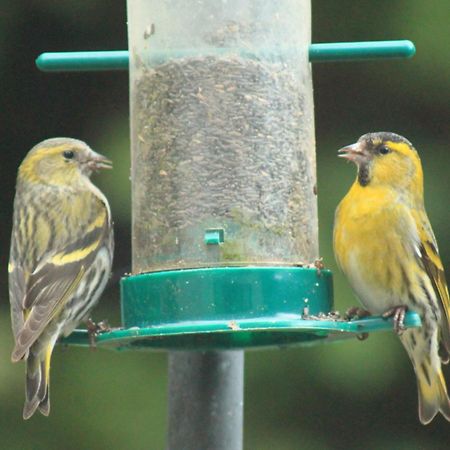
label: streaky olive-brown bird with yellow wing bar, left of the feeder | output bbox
[8,138,114,419]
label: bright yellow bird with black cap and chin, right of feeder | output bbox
[334,132,450,424]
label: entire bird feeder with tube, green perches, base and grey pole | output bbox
[37,0,420,450]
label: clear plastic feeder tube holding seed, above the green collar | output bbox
[128,0,318,273]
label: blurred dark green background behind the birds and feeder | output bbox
[0,0,450,450]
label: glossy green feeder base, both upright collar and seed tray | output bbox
[62,267,421,350]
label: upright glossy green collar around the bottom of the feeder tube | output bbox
[121,267,333,349]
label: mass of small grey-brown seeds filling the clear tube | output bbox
[132,55,318,270]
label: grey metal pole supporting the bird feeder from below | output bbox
[167,350,244,450]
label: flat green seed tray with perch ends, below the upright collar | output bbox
[61,312,421,350]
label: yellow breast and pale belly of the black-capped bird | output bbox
[333,183,417,310]
